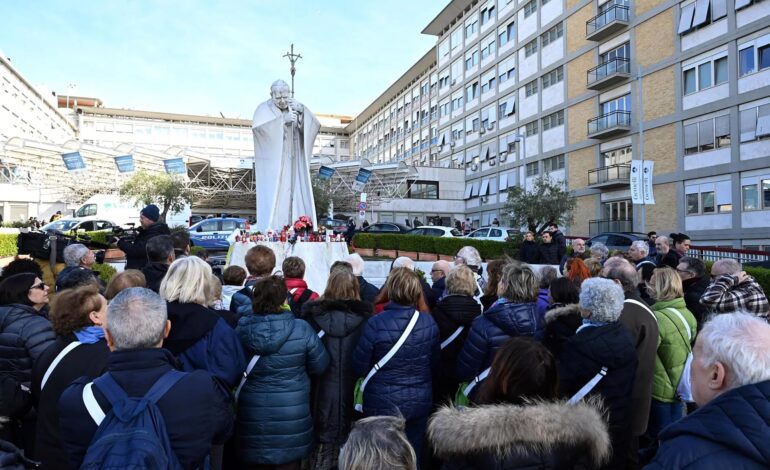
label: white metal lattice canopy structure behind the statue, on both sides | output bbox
[0,137,419,212]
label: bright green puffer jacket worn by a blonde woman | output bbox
[652,297,697,403]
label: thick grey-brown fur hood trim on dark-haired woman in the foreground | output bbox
[428,399,610,466]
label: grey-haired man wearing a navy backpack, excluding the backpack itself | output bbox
[59,287,233,468]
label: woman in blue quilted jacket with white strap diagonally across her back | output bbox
[353,268,441,456]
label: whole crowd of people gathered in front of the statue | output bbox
[0,210,770,470]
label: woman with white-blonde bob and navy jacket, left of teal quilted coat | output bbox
[159,256,246,396]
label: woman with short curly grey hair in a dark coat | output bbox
[559,278,637,469]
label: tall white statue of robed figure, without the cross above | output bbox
[251,80,321,233]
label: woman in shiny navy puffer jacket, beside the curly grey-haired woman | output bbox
[456,262,545,397]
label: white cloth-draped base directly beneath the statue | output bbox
[227,241,348,295]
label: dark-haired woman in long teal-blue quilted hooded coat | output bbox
[235,276,329,469]
